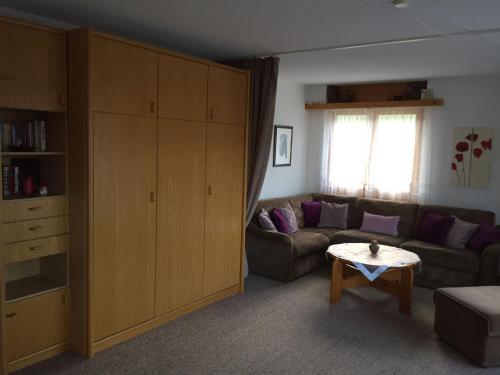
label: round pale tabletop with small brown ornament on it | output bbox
[327,243,420,268]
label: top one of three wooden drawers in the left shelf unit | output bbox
[1,197,69,223]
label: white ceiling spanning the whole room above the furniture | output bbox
[0,0,500,84]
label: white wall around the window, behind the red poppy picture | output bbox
[305,75,500,222]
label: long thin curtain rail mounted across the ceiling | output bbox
[261,27,500,57]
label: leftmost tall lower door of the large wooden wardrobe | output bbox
[91,113,156,341]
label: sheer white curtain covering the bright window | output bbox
[321,108,423,202]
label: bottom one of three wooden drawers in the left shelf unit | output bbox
[2,234,69,263]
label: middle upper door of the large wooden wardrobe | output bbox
[158,54,208,121]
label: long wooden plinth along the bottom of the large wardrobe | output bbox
[91,285,240,356]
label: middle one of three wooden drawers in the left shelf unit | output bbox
[2,216,69,244]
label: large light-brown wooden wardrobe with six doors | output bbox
[68,29,249,356]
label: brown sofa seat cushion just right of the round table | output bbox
[401,240,480,273]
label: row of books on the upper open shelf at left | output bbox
[0,120,47,152]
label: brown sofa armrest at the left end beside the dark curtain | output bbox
[246,223,293,281]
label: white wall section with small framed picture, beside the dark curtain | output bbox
[260,79,307,199]
